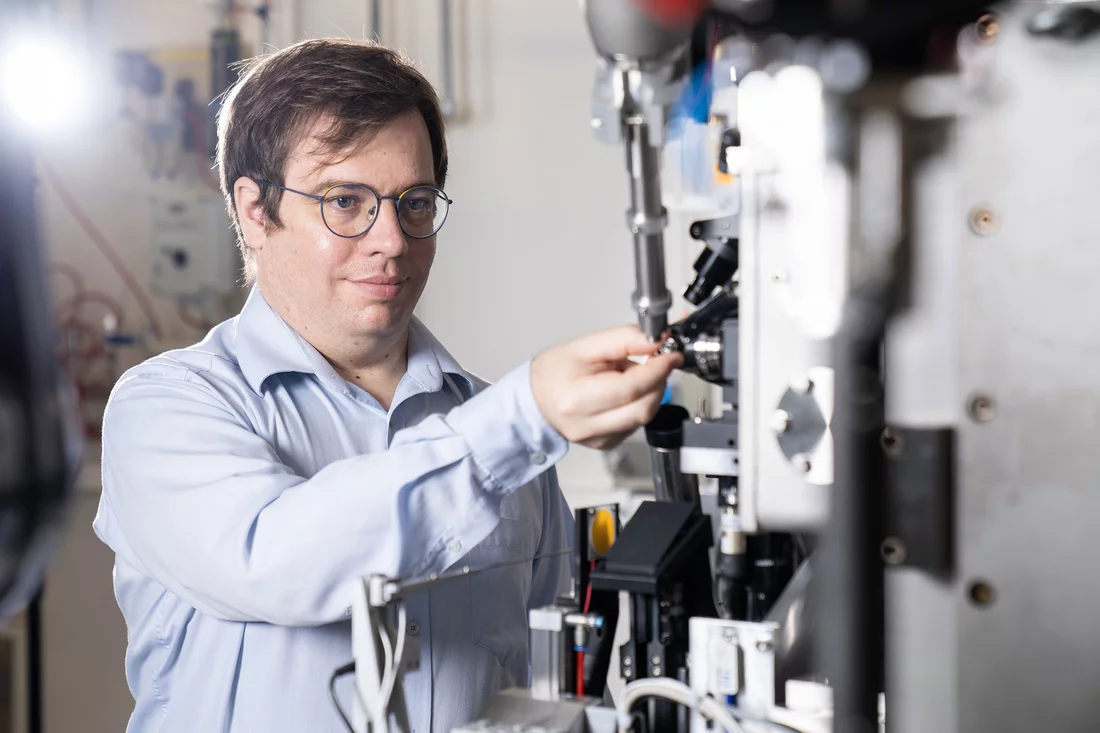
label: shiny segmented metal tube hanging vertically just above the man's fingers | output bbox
[625,119,672,341]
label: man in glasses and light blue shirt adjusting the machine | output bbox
[95,40,678,733]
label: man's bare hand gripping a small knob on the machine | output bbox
[531,326,683,450]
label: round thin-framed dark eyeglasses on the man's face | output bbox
[256,180,453,239]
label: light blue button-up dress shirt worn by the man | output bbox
[95,289,572,733]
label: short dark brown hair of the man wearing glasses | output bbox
[218,39,447,282]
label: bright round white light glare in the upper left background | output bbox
[0,36,90,131]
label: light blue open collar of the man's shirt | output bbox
[234,286,476,401]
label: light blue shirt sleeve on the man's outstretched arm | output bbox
[96,356,568,625]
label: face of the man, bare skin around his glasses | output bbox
[249,111,436,348]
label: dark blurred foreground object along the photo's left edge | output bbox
[0,0,79,622]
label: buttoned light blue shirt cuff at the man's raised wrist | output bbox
[448,362,569,492]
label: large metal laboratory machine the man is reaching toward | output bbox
[352,0,1100,733]
